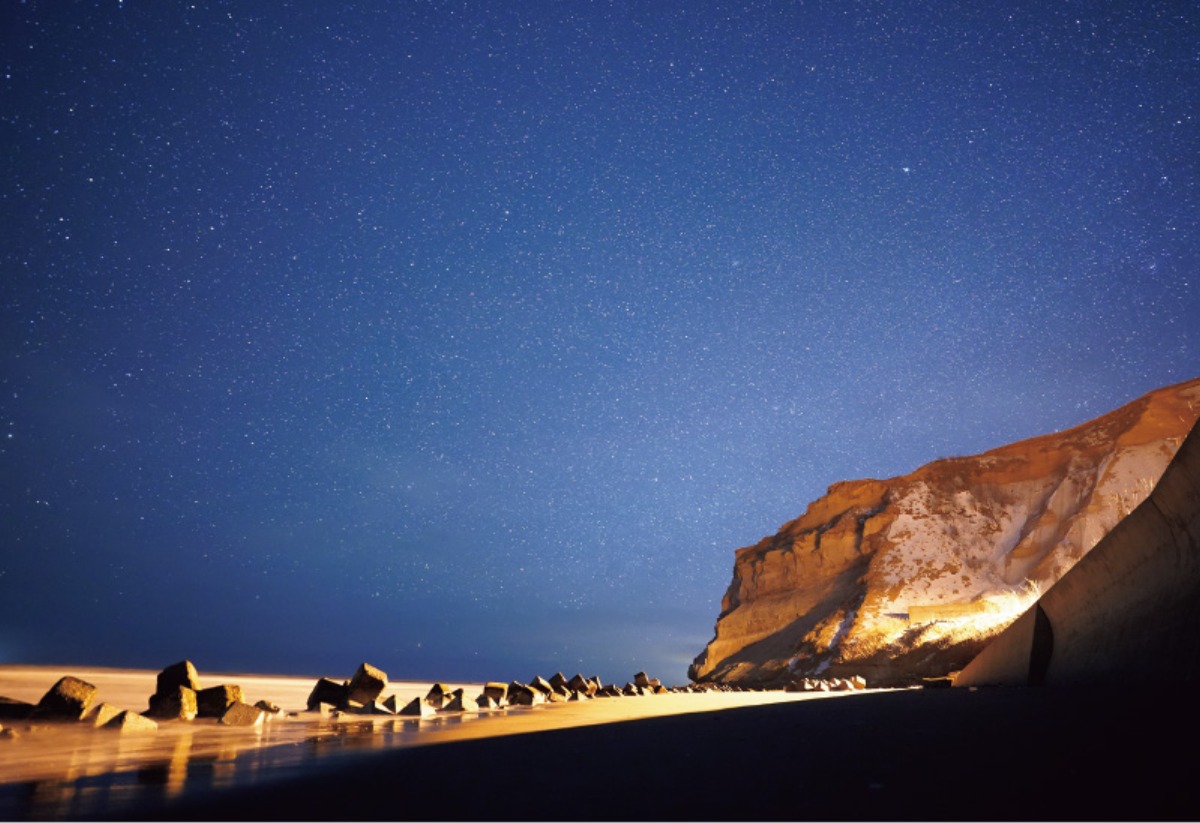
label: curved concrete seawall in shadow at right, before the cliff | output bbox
[955,425,1200,686]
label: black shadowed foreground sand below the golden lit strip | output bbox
[133,686,1200,821]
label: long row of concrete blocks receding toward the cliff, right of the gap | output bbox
[307,663,670,717]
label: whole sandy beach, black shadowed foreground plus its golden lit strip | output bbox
[0,672,1200,819]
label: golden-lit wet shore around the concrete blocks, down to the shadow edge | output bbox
[0,666,847,819]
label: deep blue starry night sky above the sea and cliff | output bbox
[0,0,1200,681]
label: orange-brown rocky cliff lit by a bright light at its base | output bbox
[689,379,1200,685]
